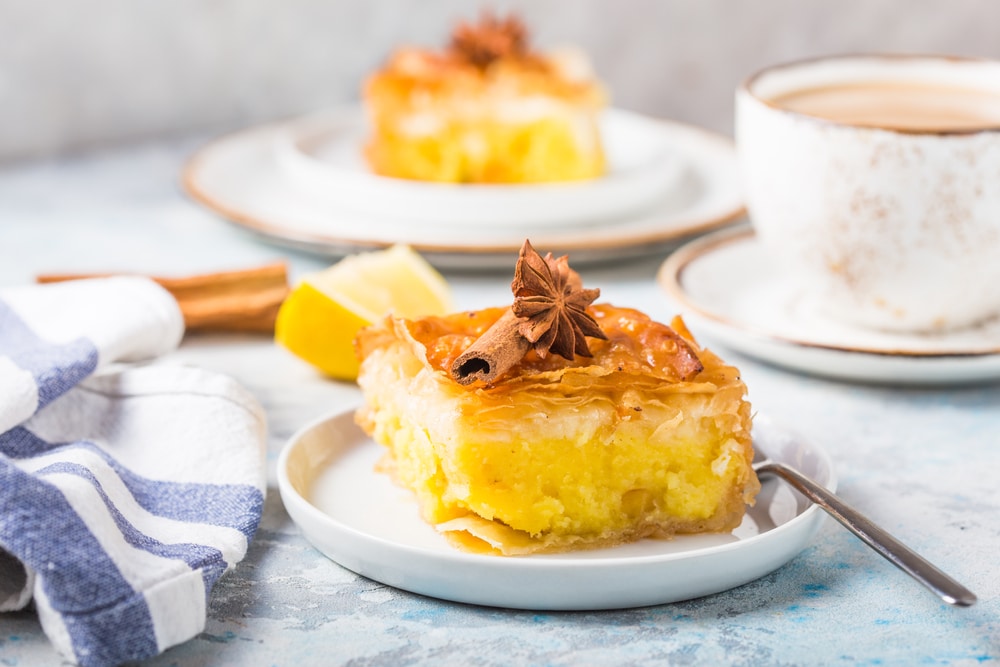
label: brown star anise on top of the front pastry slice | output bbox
[511,241,607,360]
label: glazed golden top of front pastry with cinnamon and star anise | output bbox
[358,241,720,390]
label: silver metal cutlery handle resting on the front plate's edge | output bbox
[755,461,976,607]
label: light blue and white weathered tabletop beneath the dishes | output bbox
[0,141,1000,667]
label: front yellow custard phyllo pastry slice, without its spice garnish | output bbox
[358,305,759,554]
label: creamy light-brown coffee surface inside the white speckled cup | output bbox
[768,82,1000,132]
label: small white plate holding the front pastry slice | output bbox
[278,410,835,610]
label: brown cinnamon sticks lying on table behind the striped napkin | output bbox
[36,262,288,333]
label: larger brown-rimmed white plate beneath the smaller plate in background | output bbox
[182,108,743,269]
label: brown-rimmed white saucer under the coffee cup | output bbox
[658,228,1000,384]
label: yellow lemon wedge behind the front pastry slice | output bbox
[274,245,452,380]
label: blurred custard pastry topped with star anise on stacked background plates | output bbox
[364,14,606,183]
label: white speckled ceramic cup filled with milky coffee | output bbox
[736,55,1000,332]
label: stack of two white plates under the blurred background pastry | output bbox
[184,108,743,268]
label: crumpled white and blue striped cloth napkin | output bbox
[0,277,265,665]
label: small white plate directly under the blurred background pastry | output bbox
[274,108,682,228]
